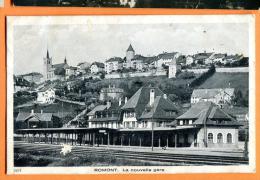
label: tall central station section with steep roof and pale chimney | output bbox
[121,87,178,129]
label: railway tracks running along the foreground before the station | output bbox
[14,142,248,165]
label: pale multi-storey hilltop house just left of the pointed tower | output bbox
[105,57,124,74]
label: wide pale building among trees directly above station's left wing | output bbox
[99,85,124,101]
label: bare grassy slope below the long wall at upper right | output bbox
[199,73,249,95]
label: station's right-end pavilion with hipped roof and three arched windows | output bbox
[171,102,240,148]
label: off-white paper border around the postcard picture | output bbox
[7,15,256,174]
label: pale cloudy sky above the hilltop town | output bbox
[13,23,249,75]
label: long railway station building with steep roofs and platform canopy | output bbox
[16,87,240,148]
